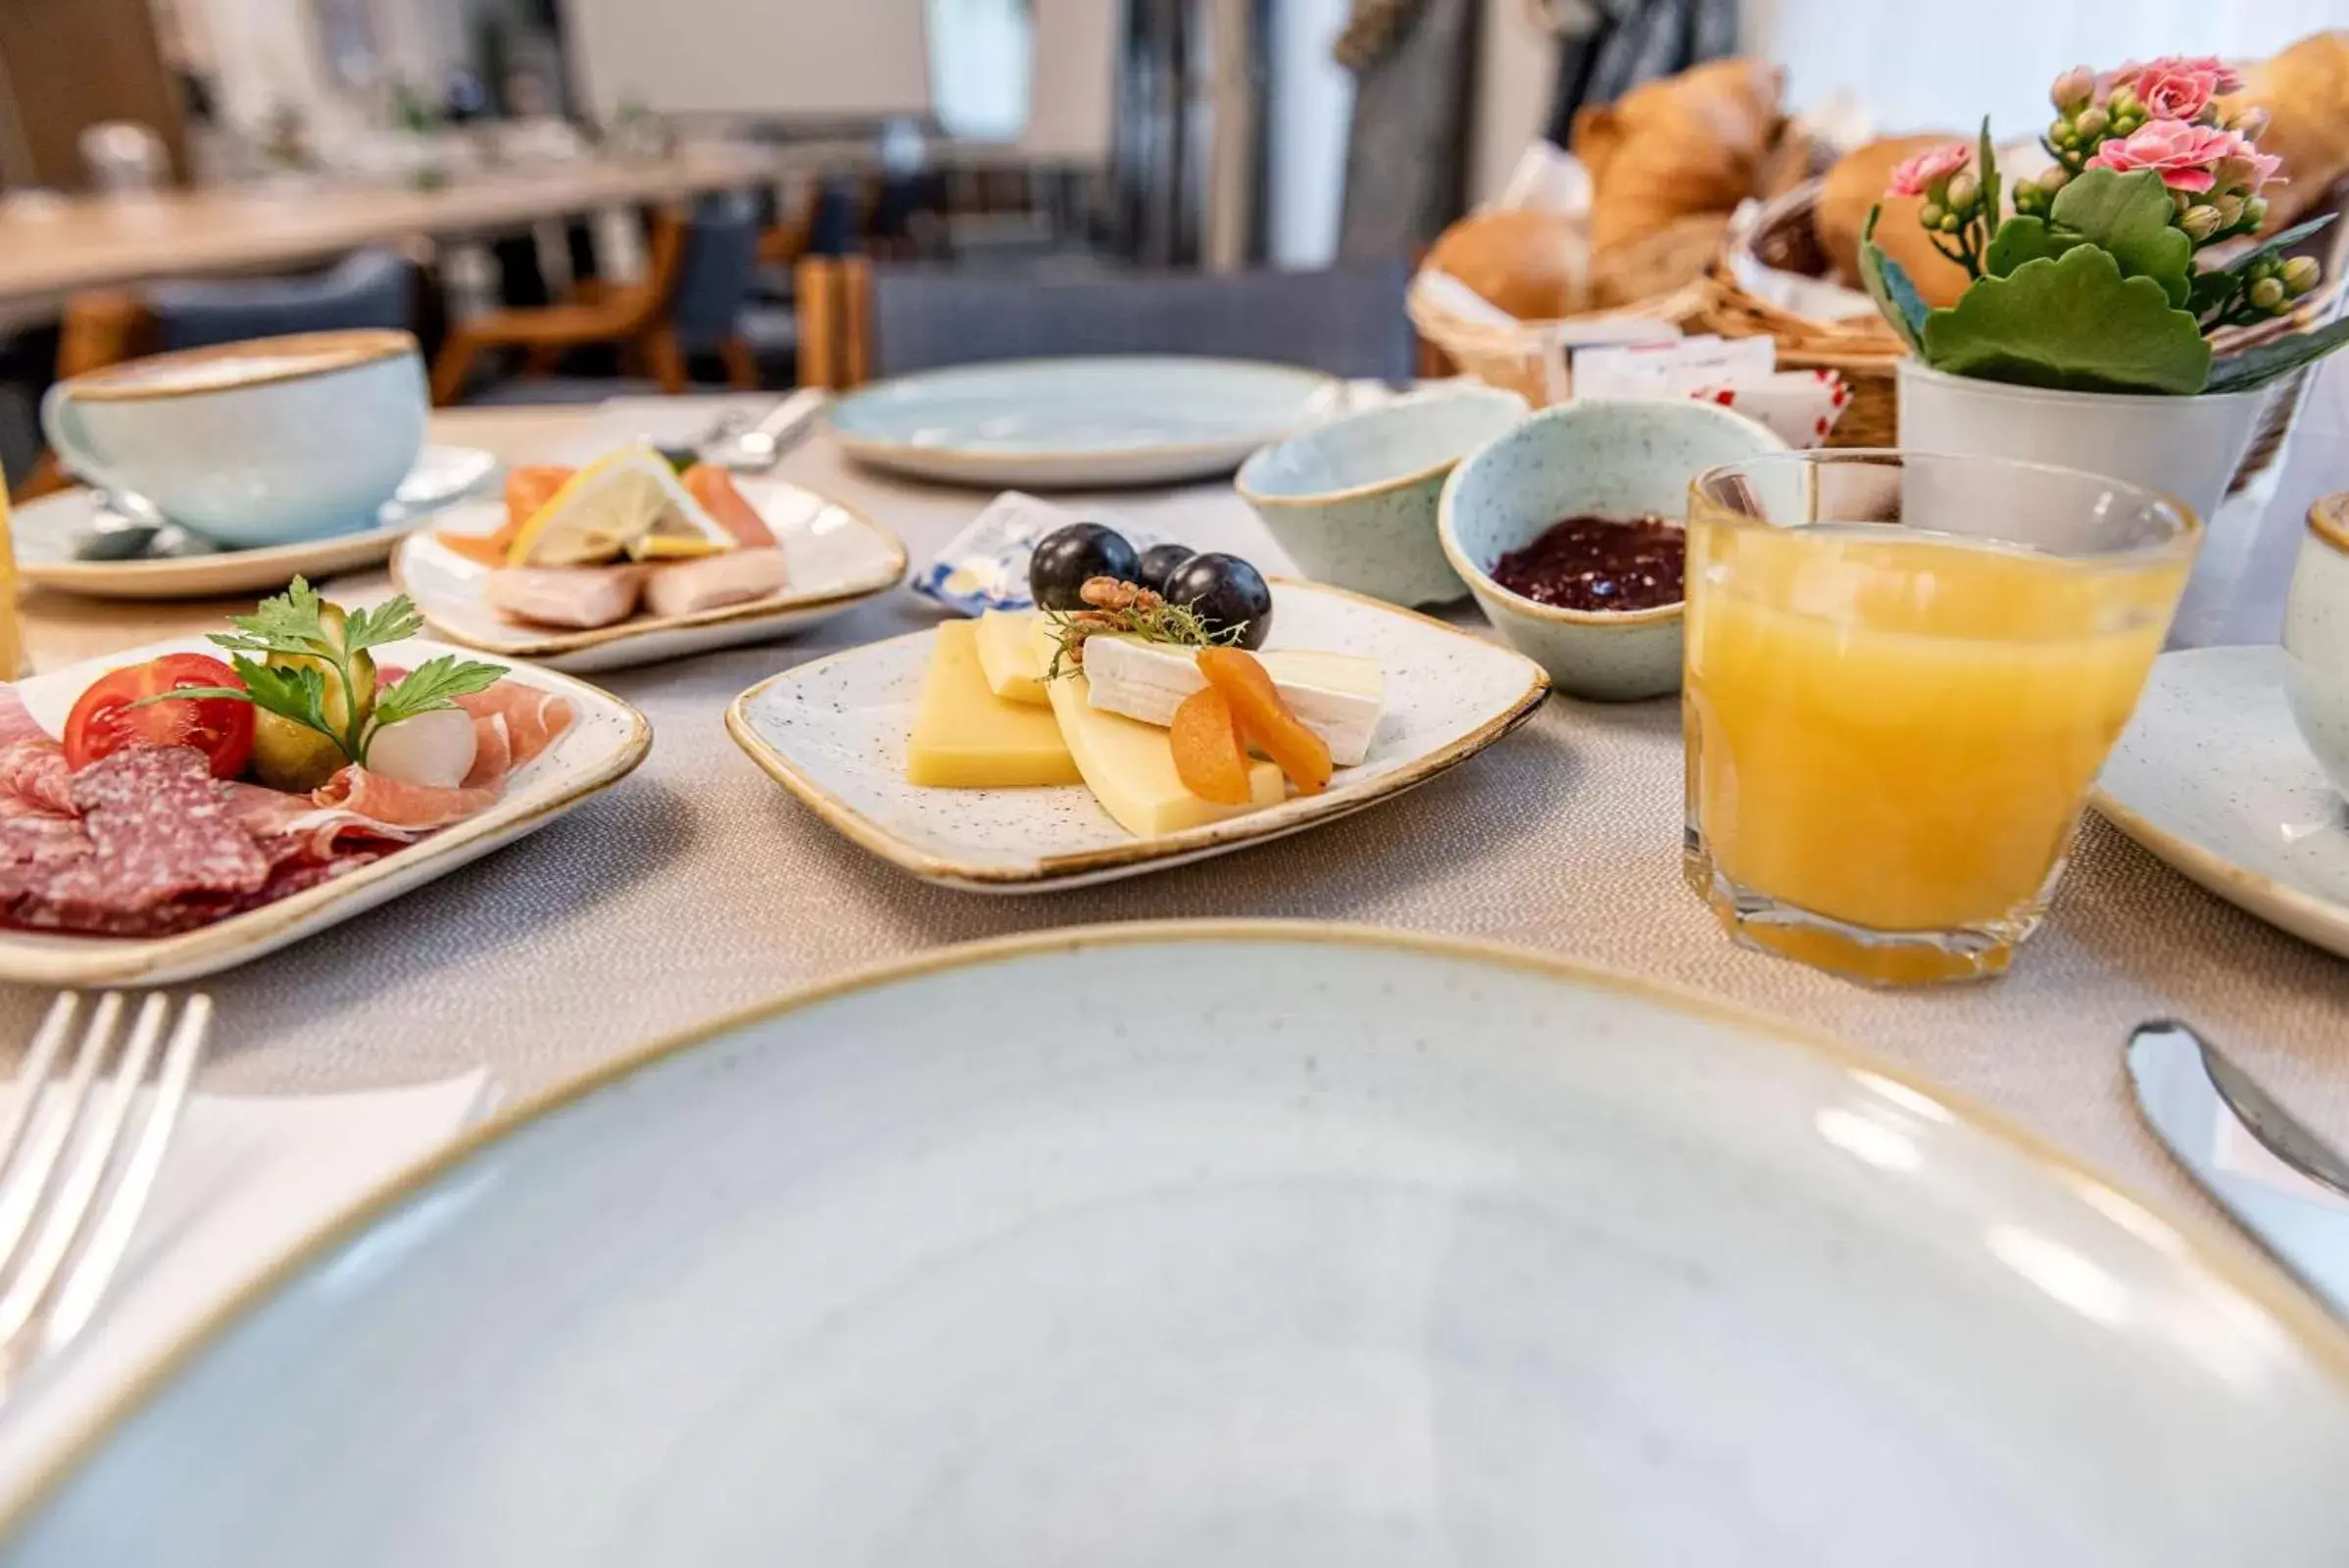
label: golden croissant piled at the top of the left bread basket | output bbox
[1574,59,1786,251]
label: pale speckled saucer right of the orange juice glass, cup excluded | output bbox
[2090,648,2349,957]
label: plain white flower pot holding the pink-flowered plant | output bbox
[1900,359,2267,523]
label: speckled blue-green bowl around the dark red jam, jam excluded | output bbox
[1436,402,1786,702]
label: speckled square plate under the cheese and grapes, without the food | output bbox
[726,582,1550,892]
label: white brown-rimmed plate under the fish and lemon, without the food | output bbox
[392,479,905,671]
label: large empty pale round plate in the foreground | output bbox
[0,925,2349,1568]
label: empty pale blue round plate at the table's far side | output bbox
[832,355,1337,488]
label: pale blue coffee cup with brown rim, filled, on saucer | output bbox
[40,331,430,547]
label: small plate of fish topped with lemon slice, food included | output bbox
[392,448,905,669]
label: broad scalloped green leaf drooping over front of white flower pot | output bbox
[1924,245,2211,394]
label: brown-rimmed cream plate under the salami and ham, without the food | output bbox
[0,627,653,986]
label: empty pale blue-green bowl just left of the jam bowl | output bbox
[1236,387,1525,604]
